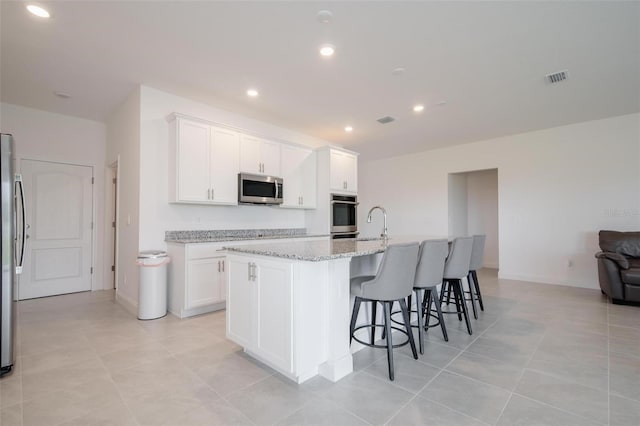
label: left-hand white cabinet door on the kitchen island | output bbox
[227,257,256,349]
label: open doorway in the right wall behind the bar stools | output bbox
[448,169,500,269]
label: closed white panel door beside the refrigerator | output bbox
[19,160,93,300]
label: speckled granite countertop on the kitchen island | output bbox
[223,235,447,262]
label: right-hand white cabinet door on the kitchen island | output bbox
[254,260,293,372]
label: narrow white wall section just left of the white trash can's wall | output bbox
[105,90,140,308]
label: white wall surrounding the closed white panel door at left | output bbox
[0,103,106,290]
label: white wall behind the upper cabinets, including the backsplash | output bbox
[140,86,327,250]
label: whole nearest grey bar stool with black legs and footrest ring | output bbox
[349,243,419,380]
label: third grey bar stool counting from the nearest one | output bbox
[440,237,473,334]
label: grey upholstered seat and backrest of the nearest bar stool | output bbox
[362,243,419,300]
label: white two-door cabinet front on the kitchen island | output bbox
[227,256,294,374]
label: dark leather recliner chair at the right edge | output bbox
[596,231,640,304]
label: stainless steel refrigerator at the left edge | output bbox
[0,133,25,376]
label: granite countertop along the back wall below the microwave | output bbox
[164,228,329,244]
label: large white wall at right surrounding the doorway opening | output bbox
[359,114,640,288]
